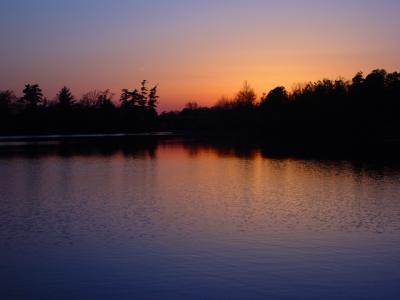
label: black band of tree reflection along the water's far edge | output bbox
[0,136,394,178]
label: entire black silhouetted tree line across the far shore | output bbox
[0,69,400,140]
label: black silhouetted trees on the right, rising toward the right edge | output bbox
[160,69,400,140]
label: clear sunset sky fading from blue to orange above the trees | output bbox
[0,0,400,111]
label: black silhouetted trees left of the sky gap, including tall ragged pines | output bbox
[0,80,159,134]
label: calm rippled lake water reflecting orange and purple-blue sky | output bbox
[0,143,400,299]
